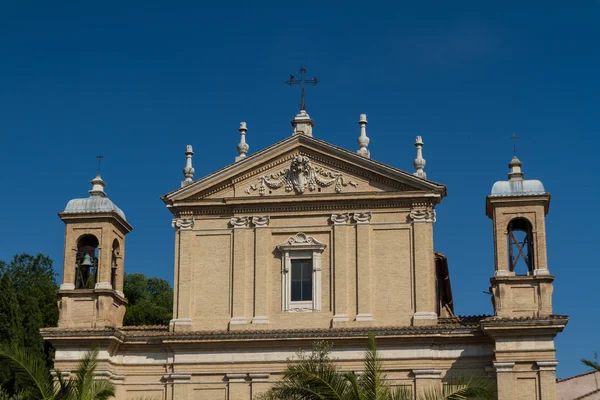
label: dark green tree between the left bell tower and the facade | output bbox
[123,273,173,325]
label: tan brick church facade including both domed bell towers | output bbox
[42,110,568,400]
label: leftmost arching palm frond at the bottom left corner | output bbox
[0,343,54,400]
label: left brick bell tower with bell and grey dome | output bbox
[58,174,133,328]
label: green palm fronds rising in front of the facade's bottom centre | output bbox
[258,335,496,400]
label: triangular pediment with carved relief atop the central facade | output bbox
[163,135,446,204]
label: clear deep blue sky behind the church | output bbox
[0,1,600,377]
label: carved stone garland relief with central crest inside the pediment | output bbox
[245,155,358,196]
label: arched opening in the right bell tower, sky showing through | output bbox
[508,218,535,275]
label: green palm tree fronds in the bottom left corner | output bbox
[0,344,115,400]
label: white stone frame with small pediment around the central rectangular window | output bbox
[277,232,326,312]
